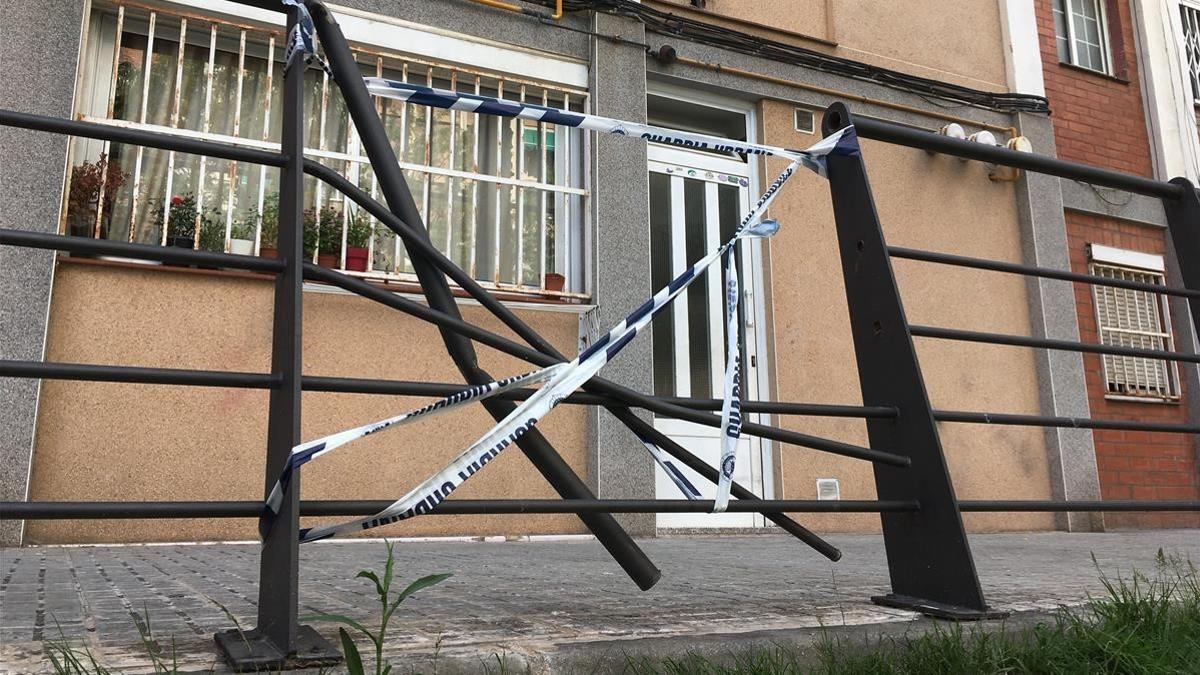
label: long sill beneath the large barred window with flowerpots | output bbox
[58,253,590,311]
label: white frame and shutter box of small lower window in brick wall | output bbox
[1087,244,1181,404]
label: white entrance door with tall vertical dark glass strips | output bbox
[649,145,770,528]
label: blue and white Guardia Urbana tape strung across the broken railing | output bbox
[260,78,859,542]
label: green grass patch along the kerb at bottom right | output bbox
[625,550,1200,675]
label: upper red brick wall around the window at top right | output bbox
[1036,0,1153,175]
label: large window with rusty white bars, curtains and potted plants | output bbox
[61,4,586,295]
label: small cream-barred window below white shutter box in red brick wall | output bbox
[1092,254,1180,401]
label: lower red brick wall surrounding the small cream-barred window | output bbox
[1067,211,1200,527]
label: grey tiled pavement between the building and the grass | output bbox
[0,530,1200,671]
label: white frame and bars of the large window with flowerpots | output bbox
[60,0,590,300]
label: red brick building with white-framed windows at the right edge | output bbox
[1037,0,1200,526]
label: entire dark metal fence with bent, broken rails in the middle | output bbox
[0,0,1200,669]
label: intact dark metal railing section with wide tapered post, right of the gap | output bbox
[823,98,1200,616]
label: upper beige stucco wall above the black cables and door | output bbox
[649,0,1008,91]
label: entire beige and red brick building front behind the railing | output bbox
[0,0,1200,543]
